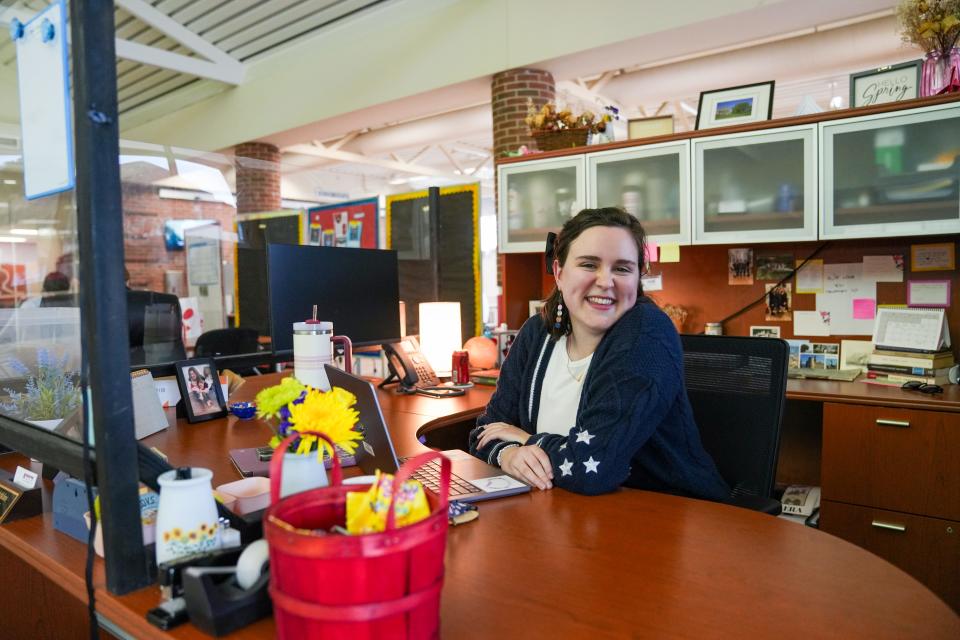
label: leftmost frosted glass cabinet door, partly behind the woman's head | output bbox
[497,156,585,253]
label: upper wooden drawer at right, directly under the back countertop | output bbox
[820,403,960,520]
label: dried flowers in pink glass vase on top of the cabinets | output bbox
[897,0,960,96]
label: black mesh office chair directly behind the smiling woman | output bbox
[680,335,790,515]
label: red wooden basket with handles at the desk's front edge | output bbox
[263,432,450,640]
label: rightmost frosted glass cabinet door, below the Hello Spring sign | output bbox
[820,104,960,238]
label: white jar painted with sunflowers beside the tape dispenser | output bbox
[157,467,220,564]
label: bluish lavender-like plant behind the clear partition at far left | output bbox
[0,349,83,420]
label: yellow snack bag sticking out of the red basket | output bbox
[347,471,430,535]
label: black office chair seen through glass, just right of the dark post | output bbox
[127,289,187,365]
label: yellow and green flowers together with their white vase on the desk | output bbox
[257,376,363,496]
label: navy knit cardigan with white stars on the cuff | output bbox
[470,298,730,501]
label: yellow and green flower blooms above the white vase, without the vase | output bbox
[257,377,363,460]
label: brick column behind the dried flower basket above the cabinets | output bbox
[491,69,556,158]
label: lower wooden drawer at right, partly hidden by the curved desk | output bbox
[820,500,960,612]
